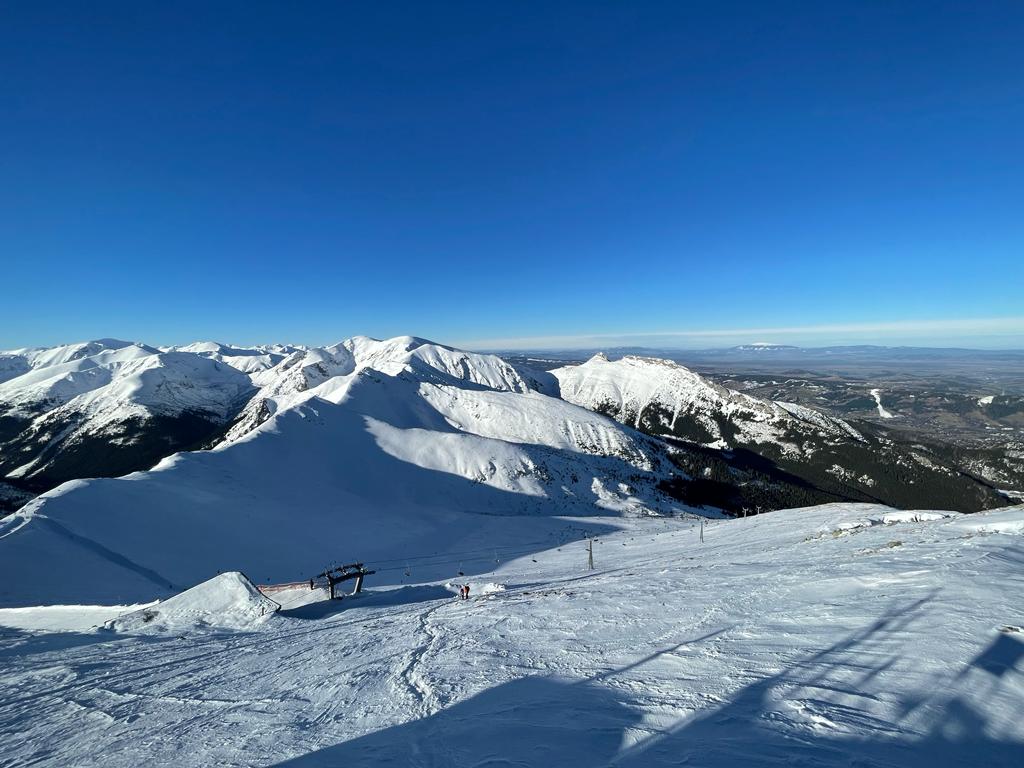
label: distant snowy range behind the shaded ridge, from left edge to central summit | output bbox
[0,337,655,518]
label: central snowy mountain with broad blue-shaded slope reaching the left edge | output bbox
[0,338,679,606]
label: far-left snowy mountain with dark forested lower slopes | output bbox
[0,339,255,490]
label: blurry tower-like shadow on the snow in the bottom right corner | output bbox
[614,596,1024,768]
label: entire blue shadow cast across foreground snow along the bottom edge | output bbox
[266,597,1024,768]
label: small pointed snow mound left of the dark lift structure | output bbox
[103,570,281,632]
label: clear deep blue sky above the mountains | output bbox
[0,0,1024,347]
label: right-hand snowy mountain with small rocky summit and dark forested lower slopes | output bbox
[550,354,1006,512]
